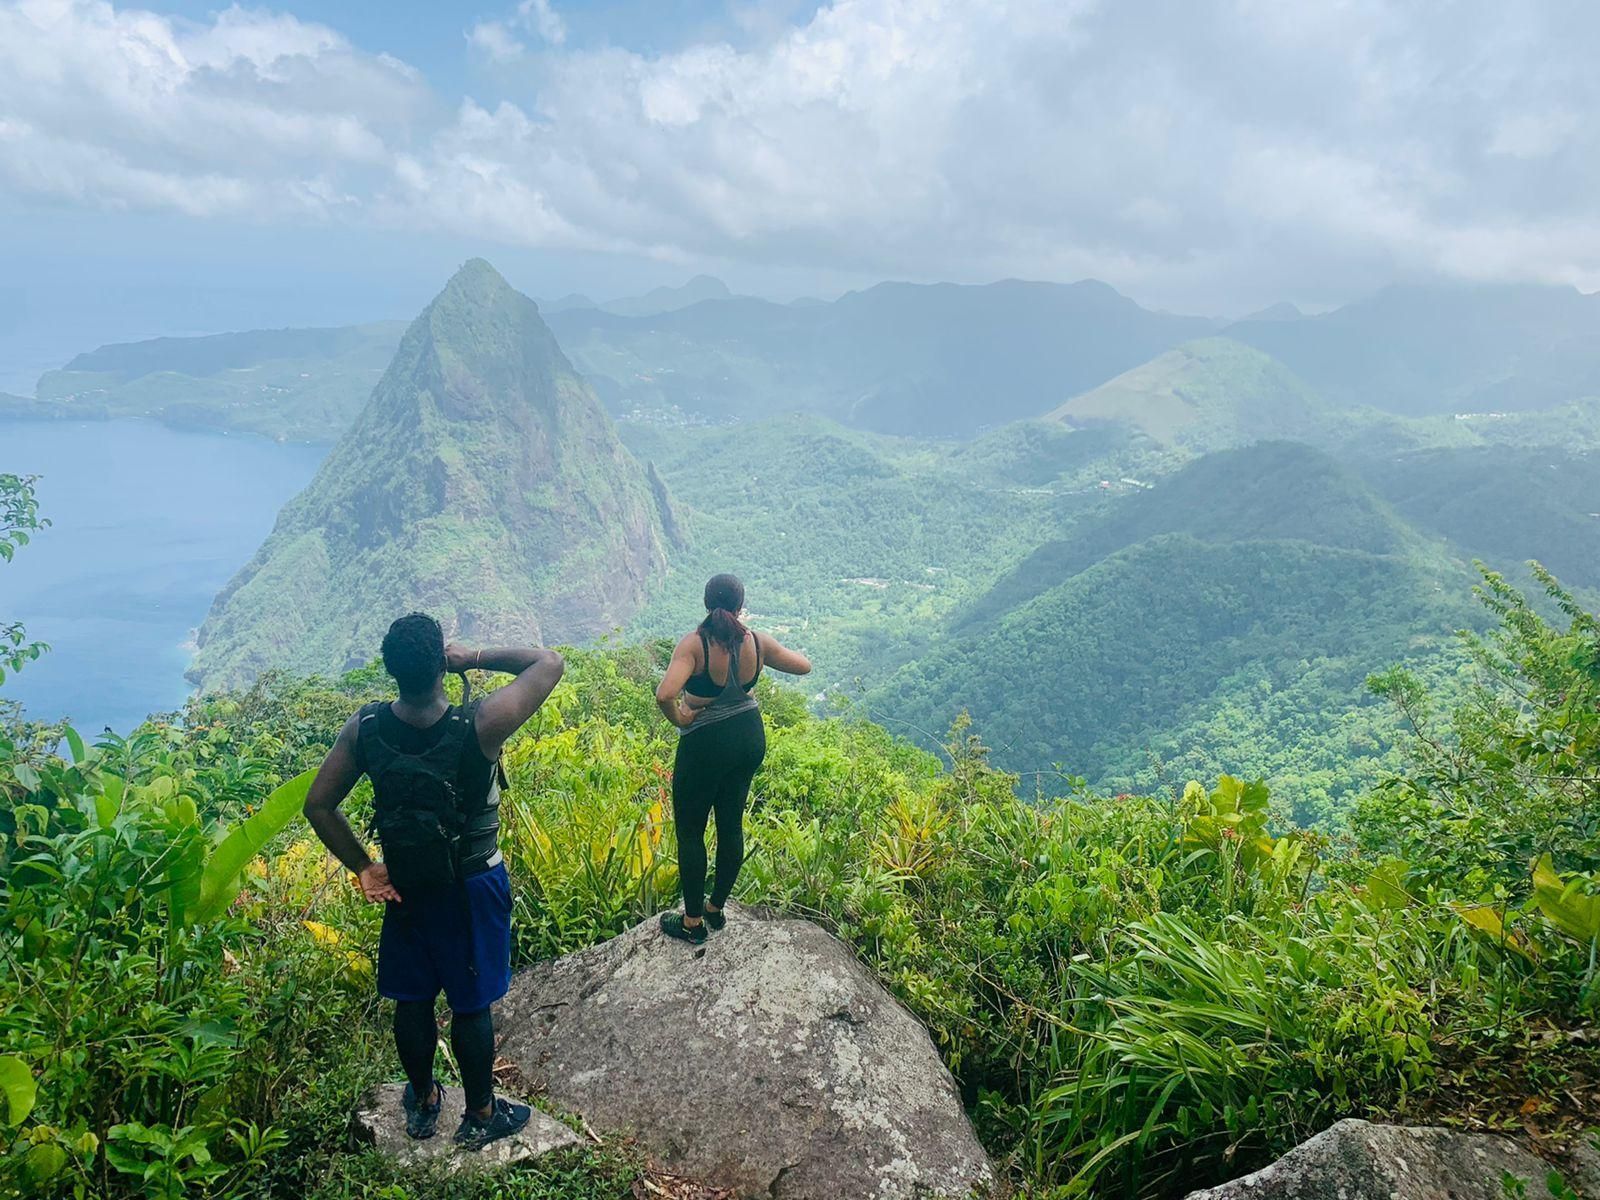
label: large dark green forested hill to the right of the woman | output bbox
[867,443,1475,819]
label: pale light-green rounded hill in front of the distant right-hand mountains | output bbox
[1050,338,1322,453]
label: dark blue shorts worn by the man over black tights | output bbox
[378,862,510,1013]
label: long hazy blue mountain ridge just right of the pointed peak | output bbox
[550,280,1214,435]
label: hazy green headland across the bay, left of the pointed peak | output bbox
[0,322,405,442]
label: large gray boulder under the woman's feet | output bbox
[496,904,992,1200]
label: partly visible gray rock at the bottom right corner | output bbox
[1187,1120,1550,1200]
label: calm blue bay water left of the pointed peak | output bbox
[0,421,326,733]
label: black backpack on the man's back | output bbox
[357,704,477,896]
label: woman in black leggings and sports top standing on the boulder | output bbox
[656,574,811,946]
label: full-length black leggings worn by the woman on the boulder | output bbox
[672,709,766,917]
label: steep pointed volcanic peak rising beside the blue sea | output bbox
[190,259,666,686]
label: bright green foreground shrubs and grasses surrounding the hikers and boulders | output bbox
[0,576,1600,1200]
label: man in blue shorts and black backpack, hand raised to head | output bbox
[306,613,565,1149]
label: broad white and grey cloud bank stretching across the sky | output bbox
[0,0,1600,306]
